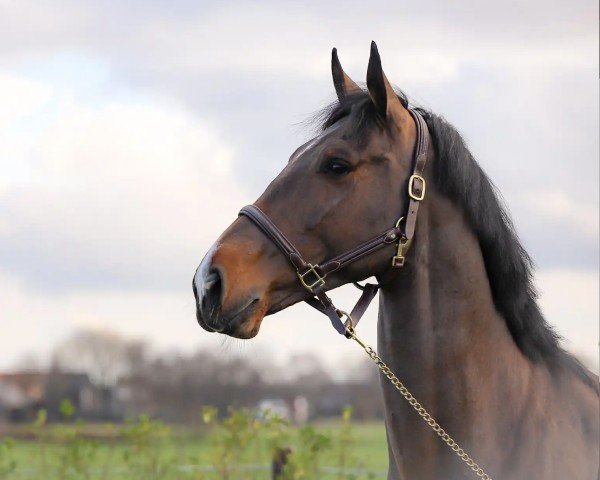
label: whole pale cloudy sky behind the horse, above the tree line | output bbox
[0,0,599,376]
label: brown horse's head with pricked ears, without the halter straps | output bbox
[193,42,416,338]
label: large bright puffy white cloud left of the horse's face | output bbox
[0,75,248,289]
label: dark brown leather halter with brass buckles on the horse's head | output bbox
[239,109,429,336]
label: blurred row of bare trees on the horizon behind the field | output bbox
[49,330,381,422]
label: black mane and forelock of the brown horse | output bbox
[315,92,599,391]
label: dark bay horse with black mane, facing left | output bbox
[192,43,600,480]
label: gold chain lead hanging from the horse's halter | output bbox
[346,324,492,480]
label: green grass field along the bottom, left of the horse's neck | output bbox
[0,414,387,480]
